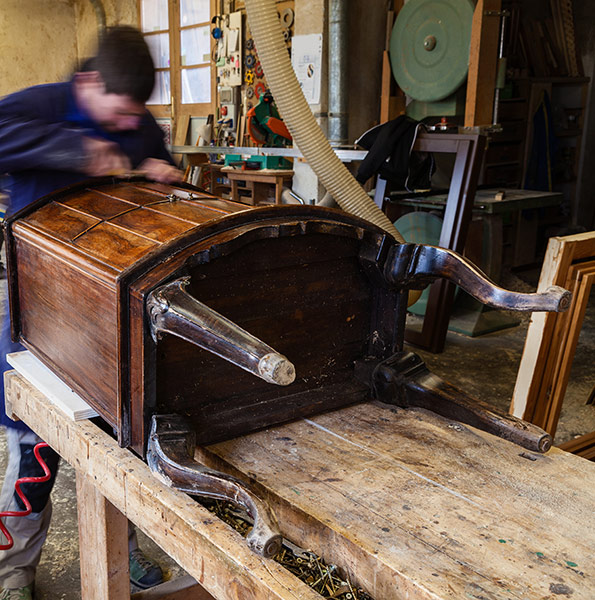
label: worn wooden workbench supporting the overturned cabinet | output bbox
[6,372,595,600]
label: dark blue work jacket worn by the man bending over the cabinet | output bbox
[0,81,173,429]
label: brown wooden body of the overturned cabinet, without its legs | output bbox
[7,179,404,454]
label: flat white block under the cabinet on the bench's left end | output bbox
[6,350,98,421]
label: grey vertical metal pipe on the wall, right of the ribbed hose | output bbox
[328,0,348,146]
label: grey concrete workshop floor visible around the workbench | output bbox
[0,273,595,600]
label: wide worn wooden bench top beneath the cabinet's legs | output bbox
[198,403,595,600]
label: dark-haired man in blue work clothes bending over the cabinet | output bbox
[0,27,181,600]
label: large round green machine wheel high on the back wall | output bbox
[390,0,475,102]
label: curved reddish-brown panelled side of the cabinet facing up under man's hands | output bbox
[15,182,246,272]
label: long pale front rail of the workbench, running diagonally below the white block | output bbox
[5,371,320,600]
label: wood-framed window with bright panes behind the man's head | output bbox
[139,0,214,118]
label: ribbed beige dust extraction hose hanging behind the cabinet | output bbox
[245,0,405,243]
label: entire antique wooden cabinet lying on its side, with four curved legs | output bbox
[5,178,569,556]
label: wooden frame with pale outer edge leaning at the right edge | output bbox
[510,231,595,456]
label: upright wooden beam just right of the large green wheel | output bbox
[465,0,502,127]
